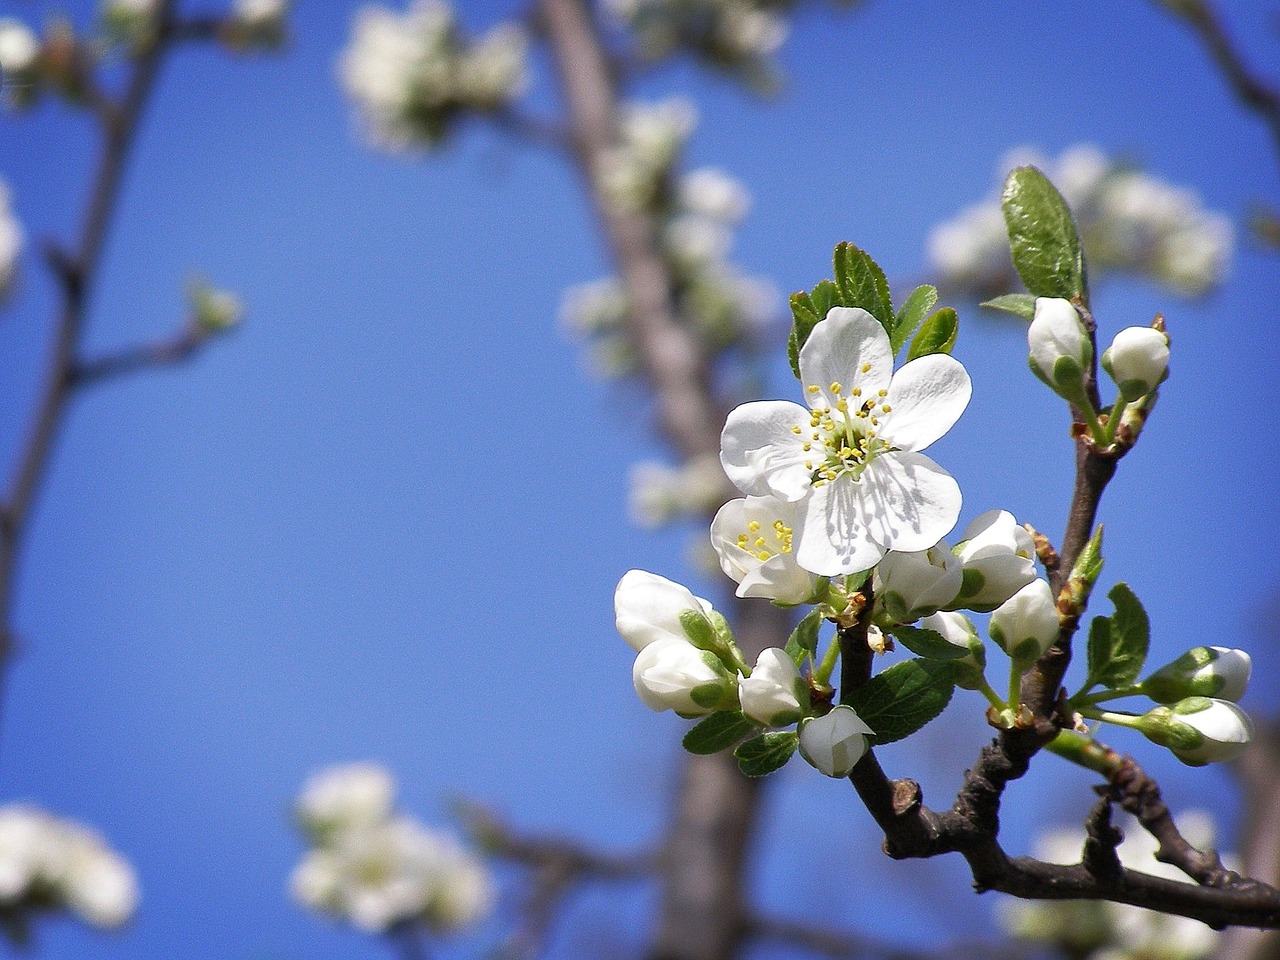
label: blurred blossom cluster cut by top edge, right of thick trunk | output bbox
[607,0,788,88]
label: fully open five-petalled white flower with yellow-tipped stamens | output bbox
[721,307,972,576]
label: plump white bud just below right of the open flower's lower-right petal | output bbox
[948,509,1036,613]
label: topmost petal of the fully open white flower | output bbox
[800,307,893,412]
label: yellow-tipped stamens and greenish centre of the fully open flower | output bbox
[795,370,895,486]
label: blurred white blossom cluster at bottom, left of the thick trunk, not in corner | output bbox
[291,763,494,933]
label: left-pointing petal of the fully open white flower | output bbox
[721,401,814,500]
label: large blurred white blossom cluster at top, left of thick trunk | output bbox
[338,0,527,150]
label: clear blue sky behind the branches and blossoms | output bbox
[0,0,1280,960]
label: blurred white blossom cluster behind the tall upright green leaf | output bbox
[928,145,1234,298]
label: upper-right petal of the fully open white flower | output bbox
[881,353,973,451]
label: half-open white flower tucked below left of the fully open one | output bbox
[712,497,818,603]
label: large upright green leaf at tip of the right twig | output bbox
[1001,166,1088,302]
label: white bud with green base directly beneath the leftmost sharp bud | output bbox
[631,637,737,717]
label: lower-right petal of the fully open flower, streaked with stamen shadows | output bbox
[854,451,960,552]
